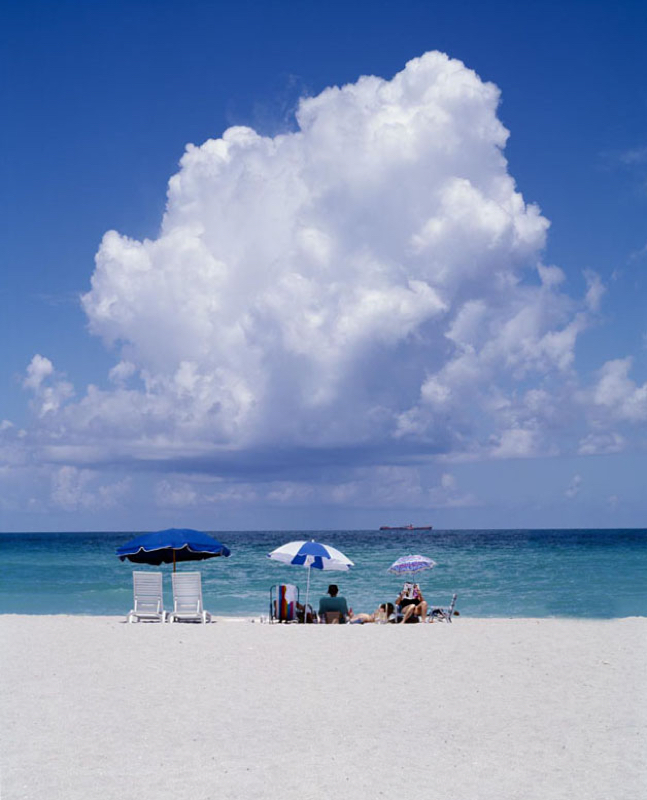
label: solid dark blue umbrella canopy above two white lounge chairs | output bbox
[117,528,231,569]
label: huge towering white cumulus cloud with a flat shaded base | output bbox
[77,53,556,450]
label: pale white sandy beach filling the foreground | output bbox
[0,615,647,800]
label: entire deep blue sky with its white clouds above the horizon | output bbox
[0,0,647,531]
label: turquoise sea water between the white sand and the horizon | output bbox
[0,530,647,618]
